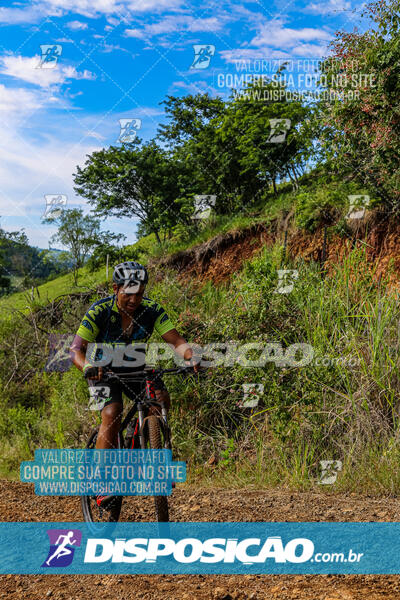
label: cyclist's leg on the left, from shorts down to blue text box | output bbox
[89,380,123,449]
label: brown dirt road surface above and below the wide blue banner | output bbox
[0,480,400,600]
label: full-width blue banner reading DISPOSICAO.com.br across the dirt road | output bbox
[0,522,400,574]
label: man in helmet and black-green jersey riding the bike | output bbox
[70,261,198,507]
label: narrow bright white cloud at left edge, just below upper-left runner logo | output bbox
[0,55,96,88]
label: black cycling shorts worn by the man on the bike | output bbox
[88,377,167,410]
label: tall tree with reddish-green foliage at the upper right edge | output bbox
[321,0,400,211]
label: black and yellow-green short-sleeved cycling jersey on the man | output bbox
[76,295,175,368]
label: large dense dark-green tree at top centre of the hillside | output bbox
[158,81,313,214]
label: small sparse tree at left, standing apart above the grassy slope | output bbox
[46,208,125,285]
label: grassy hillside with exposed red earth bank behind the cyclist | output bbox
[0,170,400,493]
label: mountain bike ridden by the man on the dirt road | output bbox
[81,366,194,523]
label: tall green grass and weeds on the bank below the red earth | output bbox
[0,237,400,494]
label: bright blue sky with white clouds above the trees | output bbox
[0,0,363,248]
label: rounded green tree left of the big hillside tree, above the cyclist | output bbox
[74,140,193,243]
